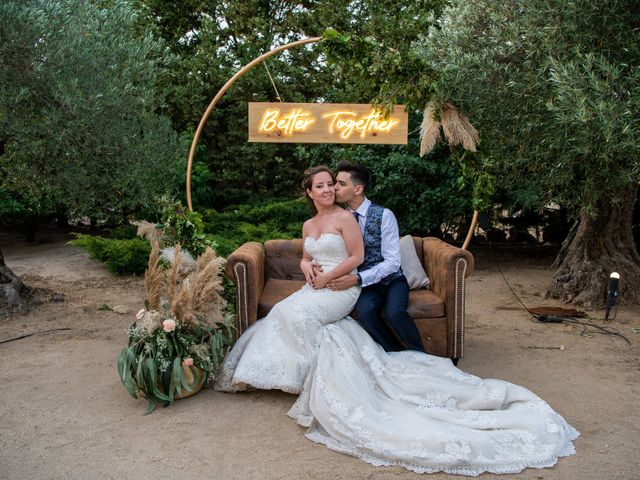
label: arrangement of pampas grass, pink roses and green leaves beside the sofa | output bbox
[118,239,235,414]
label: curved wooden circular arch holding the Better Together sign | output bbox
[187,37,478,250]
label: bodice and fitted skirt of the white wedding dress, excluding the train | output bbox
[214,233,360,393]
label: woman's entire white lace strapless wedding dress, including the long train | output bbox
[216,234,578,476]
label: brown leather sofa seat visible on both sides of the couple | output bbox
[258,278,445,318]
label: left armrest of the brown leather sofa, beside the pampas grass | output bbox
[225,242,264,336]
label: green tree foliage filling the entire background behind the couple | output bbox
[0,0,638,270]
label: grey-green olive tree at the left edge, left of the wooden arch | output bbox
[0,0,184,310]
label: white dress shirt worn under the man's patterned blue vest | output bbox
[355,197,400,287]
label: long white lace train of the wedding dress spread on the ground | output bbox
[289,320,578,476]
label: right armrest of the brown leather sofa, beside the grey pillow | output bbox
[422,237,474,358]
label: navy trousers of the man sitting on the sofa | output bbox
[355,275,425,352]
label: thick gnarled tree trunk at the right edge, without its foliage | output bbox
[548,185,640,310]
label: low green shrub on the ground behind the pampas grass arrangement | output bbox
[69,233,151,275]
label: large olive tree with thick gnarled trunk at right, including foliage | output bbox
[416,0,640,308]
